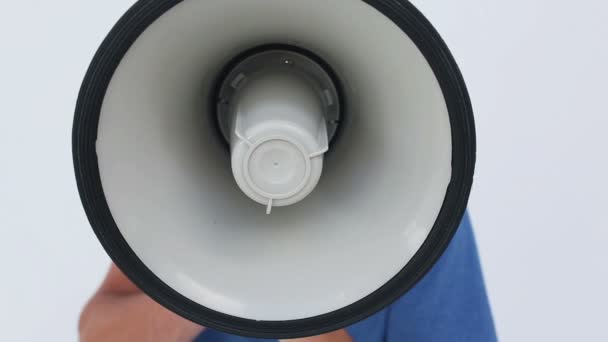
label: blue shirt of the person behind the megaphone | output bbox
[197,216,497,342]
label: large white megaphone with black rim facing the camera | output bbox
[73,0,475,338]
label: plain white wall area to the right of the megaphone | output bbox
[417,0,608,342]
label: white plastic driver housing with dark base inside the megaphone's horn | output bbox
[218,50,340,214]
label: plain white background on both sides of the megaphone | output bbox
[0,0,608,342]
